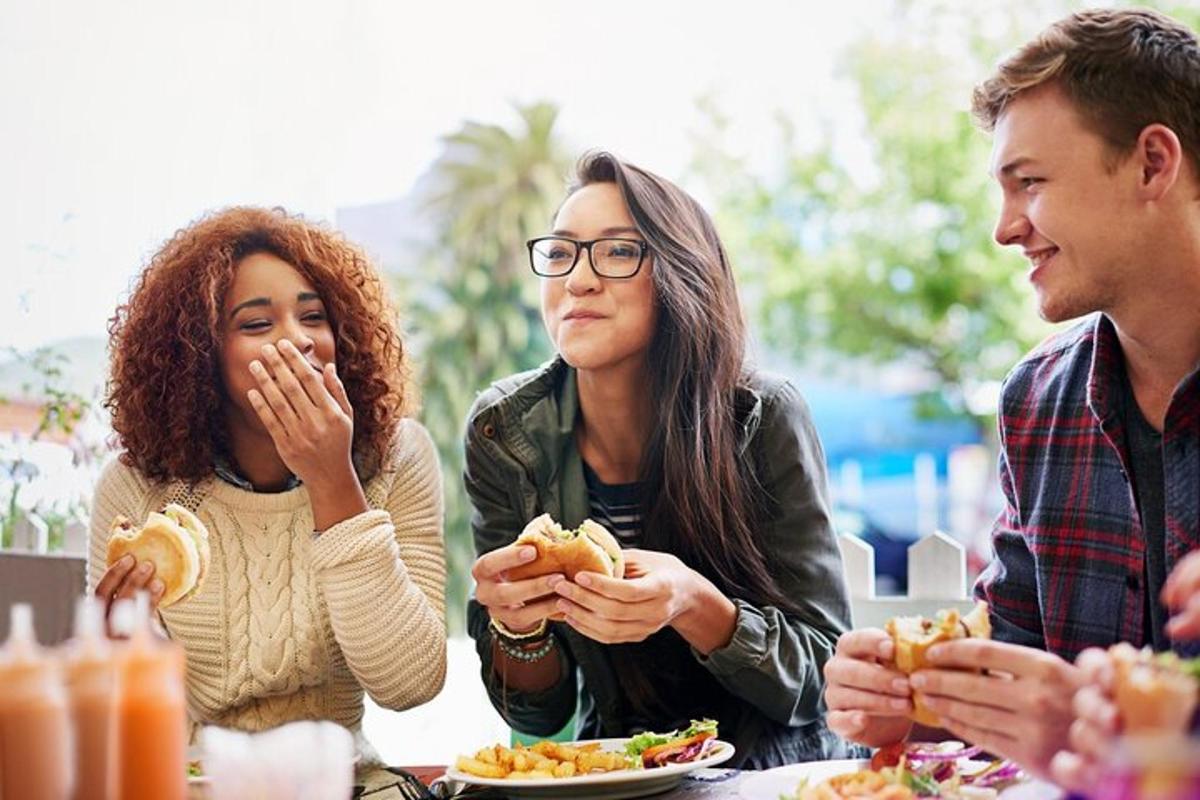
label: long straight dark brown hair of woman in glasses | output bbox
[570,152,794,609]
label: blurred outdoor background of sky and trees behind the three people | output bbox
[0,0,1200,763]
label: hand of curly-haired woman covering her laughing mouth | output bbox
[246,339,367,530]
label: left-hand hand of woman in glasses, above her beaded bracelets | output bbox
[470,545,564,633]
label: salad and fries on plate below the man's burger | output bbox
[780,741,1025,800]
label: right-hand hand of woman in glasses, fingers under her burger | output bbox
[554,548,737,652]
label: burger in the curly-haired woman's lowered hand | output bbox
[107,503,211,608]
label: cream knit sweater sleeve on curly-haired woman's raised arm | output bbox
[312,420,446,710]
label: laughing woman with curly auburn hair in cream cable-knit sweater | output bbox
[89,207,445,765]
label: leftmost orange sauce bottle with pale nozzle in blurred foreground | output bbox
[0,603,73,800]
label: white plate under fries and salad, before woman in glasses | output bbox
[446,739,734,800]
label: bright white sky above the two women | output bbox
[0,0,897,349]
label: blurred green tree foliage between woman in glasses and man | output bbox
[696,0,1200,432]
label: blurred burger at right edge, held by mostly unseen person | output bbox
[1109,642,1200,734]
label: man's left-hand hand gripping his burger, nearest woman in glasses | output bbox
[824,627,912,747]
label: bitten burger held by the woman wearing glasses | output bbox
[508,513,625,620]
